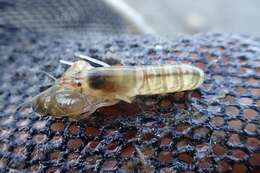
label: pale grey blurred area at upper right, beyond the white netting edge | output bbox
[124,0,260,36]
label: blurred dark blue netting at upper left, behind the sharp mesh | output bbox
[0,0,129,35]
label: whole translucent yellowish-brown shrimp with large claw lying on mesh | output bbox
[18,55,204,119]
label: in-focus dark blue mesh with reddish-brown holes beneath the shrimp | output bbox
[0,29,260,172]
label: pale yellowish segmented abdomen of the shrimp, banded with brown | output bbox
[136,64,204,95]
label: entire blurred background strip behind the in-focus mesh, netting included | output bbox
[0,0,260,37]
